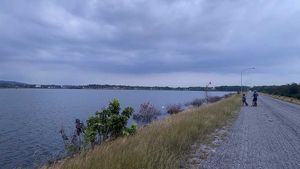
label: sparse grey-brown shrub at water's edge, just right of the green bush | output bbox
[133,102,160,123]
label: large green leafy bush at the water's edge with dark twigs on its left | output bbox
[60,99,137,151]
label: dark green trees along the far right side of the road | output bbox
[253,83,300,99]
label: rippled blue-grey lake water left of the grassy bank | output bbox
[0,89,230,168]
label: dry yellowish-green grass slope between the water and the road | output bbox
[45,96,241,169]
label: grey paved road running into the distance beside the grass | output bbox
[201,96,300,169]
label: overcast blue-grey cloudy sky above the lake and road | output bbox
[0,0,300,87]
